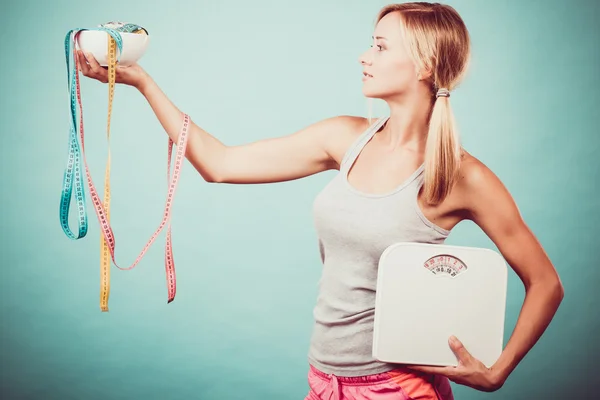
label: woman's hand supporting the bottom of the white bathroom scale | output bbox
[405,337,504,392]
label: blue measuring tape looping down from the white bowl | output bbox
[59,22,148,240]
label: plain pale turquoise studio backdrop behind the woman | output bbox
[0,0,600,400]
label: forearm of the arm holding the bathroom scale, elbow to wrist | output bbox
[492,281,563,382]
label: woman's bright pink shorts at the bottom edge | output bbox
[304,365,454,400]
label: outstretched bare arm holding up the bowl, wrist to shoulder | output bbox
[138,77,363,184]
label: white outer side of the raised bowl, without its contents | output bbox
[75,31,150,67]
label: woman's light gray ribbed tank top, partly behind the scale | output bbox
[308,117,450,376]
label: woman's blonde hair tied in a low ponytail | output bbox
[369,2,471,204]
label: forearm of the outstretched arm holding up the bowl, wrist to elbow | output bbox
[137,76,227,182]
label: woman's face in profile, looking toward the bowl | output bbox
[359,12,418,99]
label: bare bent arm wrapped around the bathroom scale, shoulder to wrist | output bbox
[465,163,564,384]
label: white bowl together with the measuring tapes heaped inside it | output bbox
[75,22,150,67]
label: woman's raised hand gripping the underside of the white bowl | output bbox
[77,50,148,89]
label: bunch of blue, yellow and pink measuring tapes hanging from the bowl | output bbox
[60,23,190,312]
